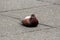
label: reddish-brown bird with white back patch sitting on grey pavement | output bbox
[22,14,39,27]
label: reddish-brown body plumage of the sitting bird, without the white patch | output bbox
[22,15,38,26]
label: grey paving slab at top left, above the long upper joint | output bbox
[0,0,49,11]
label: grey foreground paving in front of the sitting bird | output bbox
[0,16,60,40]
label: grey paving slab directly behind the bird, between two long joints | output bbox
[0,5,60,27]
